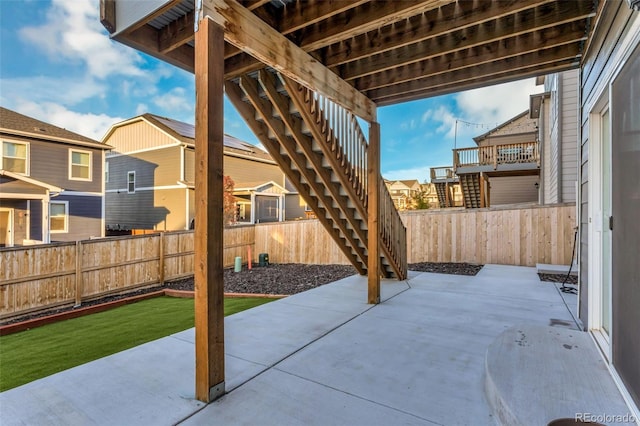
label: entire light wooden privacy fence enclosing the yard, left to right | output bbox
[0,205,576,319]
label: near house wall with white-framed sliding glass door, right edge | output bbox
[578,1,640,412]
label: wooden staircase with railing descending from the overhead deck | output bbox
[225,69,407,280]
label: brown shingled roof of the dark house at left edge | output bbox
[0,107,112,149]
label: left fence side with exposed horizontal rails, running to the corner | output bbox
[0,226,255,319]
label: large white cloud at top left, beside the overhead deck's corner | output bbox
[19,0,146,79]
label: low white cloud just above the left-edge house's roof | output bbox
[14,102,125,141]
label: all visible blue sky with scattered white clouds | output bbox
[0,0,543,182]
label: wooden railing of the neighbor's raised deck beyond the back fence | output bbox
[453,142,540,170]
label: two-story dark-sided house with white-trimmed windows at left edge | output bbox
[0,107,110,247]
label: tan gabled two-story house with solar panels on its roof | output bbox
[103,114,305,230]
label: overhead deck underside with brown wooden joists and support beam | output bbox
[101,0,604,110]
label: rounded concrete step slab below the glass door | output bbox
[485,325,633,426]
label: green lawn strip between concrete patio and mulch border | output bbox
[0,297,274,391]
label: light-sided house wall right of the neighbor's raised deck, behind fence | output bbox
[529,70,579,204]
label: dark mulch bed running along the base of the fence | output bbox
[0,262,482,325]
